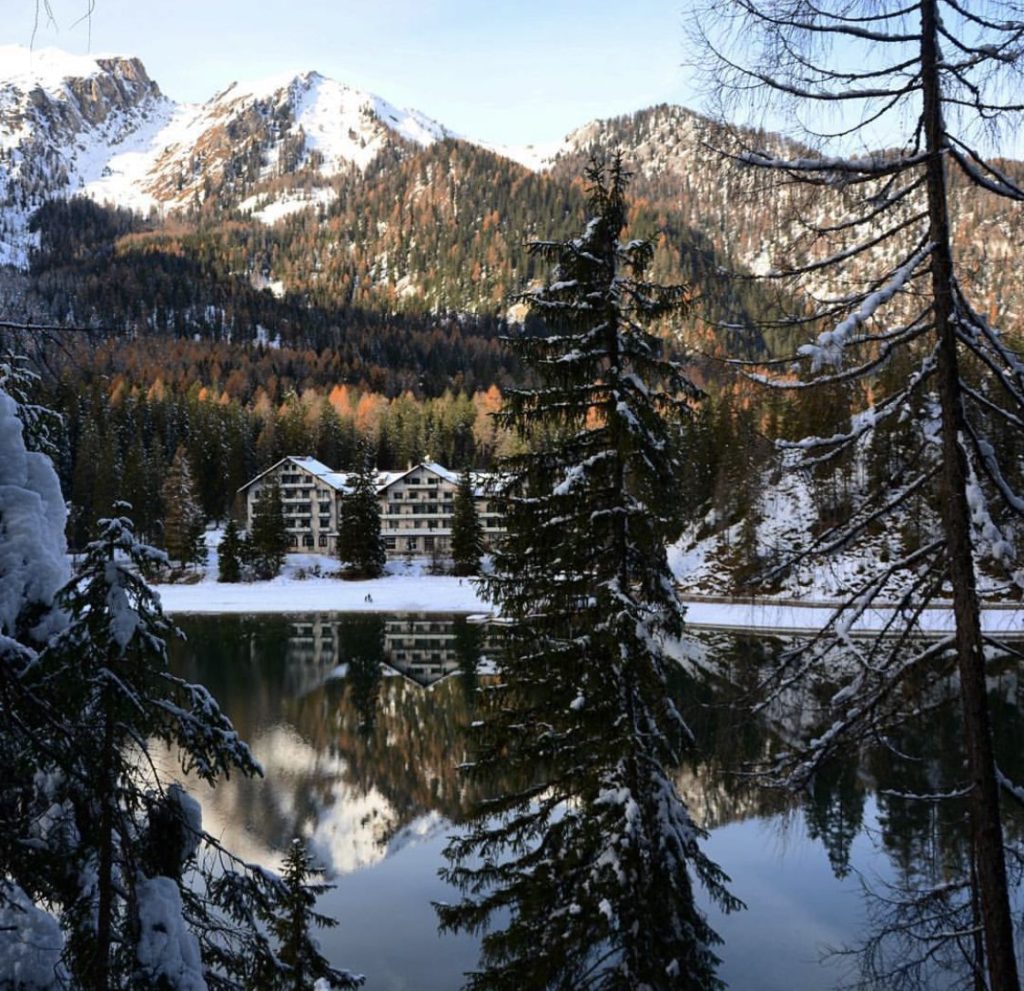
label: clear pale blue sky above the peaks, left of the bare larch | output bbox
[0,0,699,144]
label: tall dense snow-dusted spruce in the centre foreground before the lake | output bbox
[438,157,738,991]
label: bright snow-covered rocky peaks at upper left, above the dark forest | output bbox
[0,45,453,266]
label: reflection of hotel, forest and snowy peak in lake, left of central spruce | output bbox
[173,614,495,872]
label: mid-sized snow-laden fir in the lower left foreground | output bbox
[23,517,260,991]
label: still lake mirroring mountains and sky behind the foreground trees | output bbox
[172,613,1024,991]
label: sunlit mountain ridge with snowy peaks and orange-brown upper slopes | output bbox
[0,49,1024,348]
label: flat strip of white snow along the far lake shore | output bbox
[155,573,1024,638]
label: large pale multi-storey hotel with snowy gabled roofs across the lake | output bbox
[239,456,502,560]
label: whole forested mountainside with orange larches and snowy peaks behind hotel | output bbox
[0,54,1024,585]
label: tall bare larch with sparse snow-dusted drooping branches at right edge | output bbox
[692,0,1024,991]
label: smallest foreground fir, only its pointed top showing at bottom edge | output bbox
[249,838,364,991]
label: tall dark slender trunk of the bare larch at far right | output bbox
[921,0,1020,991]
